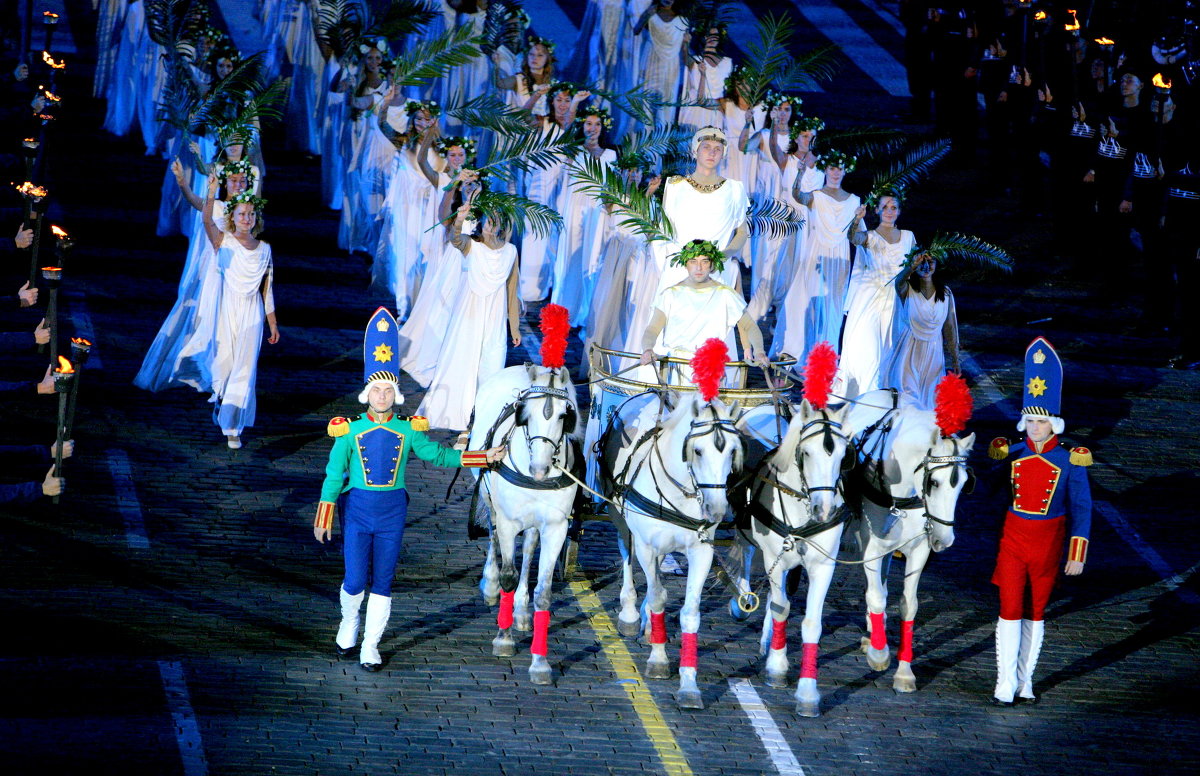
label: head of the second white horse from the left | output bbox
[664,395,745,523]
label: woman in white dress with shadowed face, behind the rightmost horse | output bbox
[888,255,960,409]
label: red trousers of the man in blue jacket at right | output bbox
[991,512,1067,620]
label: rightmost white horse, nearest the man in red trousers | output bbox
[847,390,974,692]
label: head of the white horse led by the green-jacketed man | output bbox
[512,365,580,481]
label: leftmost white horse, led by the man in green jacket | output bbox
[469,365,580,685]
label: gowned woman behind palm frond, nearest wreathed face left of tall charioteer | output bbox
[551,106,617,325]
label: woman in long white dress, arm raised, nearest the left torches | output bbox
[204,179,280,450]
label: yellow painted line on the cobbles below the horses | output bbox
[570,579,692,776]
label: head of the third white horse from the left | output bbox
[775,399,854,523]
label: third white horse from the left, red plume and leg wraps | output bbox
[730,399,854,717]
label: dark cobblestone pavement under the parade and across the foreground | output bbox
[0,4,1200,776]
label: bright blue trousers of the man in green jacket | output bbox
[341,488,408,596]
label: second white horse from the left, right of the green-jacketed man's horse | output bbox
[601,393,744,709]
